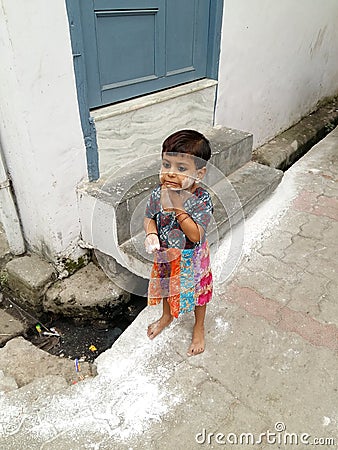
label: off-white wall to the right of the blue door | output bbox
[215,0,338,147]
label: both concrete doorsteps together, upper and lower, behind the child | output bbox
[78,127,283,286]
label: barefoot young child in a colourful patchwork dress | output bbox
[144,130,213,356]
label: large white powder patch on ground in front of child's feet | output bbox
[0,308,183,442]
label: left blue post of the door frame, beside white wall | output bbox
[66,0,100,181]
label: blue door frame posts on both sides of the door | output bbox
[65,0,224,181]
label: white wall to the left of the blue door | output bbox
[0,0,87,260]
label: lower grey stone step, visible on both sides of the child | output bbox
[119,161,283,278]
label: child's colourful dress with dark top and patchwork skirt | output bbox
[145,186,213,317]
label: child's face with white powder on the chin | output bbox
[160,153,206,190]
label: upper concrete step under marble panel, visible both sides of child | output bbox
[78,127,252,251]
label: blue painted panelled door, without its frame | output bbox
[79,0,212,108]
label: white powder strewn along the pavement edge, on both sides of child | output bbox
[0,149,318,448]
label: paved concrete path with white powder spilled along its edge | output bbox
[0,128,338,450]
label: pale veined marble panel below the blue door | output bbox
[92,80,216,174]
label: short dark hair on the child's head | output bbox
[162,130,211,169]
